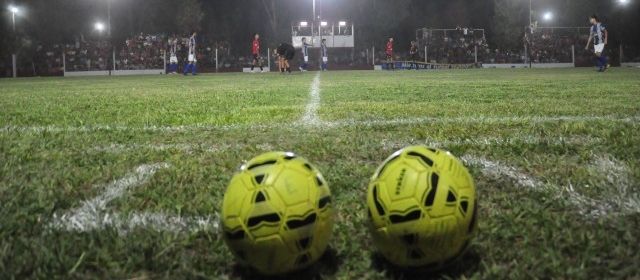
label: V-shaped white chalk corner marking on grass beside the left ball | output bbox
[50,163,218,234]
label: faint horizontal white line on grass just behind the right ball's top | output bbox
[382,135,603,150]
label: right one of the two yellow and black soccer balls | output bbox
[367,146,477,269]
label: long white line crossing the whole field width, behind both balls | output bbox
[0,115,640,134]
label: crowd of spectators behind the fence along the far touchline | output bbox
[6,26,640,76]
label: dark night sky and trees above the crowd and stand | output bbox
[0,0,640,56]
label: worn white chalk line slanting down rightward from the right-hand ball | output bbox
[461,155,640,218]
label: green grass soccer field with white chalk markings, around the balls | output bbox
[0,69,640,279]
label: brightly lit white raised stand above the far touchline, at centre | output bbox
[291,21,355,48]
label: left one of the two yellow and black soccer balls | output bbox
[221,152,334,275]
